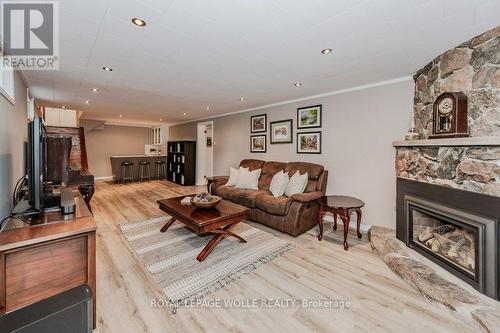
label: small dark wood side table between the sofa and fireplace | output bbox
[318,195,365,251]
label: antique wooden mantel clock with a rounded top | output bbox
[429,92,469,139]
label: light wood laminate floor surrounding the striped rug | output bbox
[92,181,479,333]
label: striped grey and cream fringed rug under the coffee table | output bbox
[120,216,294,306]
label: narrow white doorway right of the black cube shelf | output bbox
[196,121,214,185]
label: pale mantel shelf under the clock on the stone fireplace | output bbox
[392,136,500,148]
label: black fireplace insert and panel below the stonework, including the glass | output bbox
[396,178,500,300]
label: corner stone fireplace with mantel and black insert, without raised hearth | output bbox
[393,27,500,300]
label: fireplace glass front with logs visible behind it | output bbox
[409,205,478,281]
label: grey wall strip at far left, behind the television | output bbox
[0,72,27,219]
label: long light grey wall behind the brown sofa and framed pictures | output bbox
[170,79,414,228]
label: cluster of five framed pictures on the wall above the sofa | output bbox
[250,104,323,154]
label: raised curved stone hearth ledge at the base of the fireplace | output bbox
[368,226,500,333]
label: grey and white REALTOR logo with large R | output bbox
[1,1,59,70]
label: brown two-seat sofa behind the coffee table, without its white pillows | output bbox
[211,159,328,236]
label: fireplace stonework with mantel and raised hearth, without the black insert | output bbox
[369,27,500,332]
